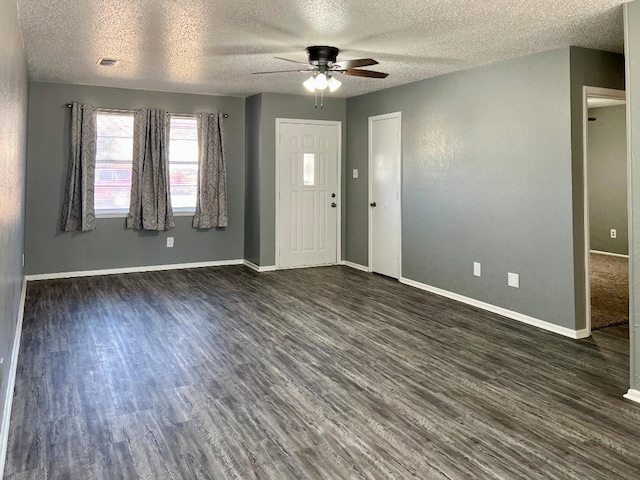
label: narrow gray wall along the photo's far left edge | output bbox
[0,0,28,436]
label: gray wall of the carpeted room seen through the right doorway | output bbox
[587,105,629,255]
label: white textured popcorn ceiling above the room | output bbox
[18,0,624,97]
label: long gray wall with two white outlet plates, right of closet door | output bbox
[346,48,576,329]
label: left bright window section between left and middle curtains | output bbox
[94,112,133,216]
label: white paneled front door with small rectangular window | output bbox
[276,120,340,268]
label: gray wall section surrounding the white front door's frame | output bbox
[252,93,347,266]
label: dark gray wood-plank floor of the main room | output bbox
[5,266,640,480]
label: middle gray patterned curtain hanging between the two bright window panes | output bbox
[127,109,175,231]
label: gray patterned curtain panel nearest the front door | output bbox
[193,113,229,228]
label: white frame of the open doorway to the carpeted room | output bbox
[582,86,632,337]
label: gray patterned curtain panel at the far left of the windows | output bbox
[60,103,96,232]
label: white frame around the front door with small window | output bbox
[275,118,343,270]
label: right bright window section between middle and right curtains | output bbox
[169,116,198,213]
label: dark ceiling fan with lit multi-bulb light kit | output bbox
[254,46,389,97]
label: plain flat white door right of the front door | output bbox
[369,112,401,278]
